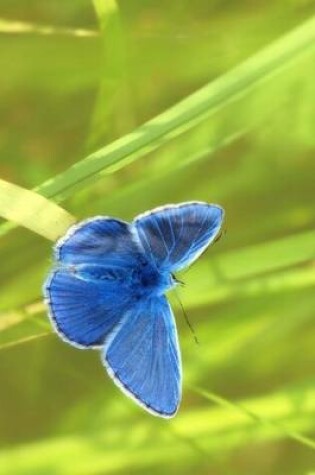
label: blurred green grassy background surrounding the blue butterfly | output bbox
[0,0,315,475]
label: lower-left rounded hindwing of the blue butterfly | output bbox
[44,268,131,348]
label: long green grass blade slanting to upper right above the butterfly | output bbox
[2,18,315,240]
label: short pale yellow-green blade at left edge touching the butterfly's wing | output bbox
[0,179,75,241]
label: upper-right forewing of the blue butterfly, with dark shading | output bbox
[134,202,224,272]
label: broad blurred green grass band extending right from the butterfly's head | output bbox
[181,231,315,306]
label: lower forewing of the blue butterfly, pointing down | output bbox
[102,296,181,417]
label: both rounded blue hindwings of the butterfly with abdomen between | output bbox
[43,217,144,348]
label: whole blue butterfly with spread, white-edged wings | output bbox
[44,202,224,418]
